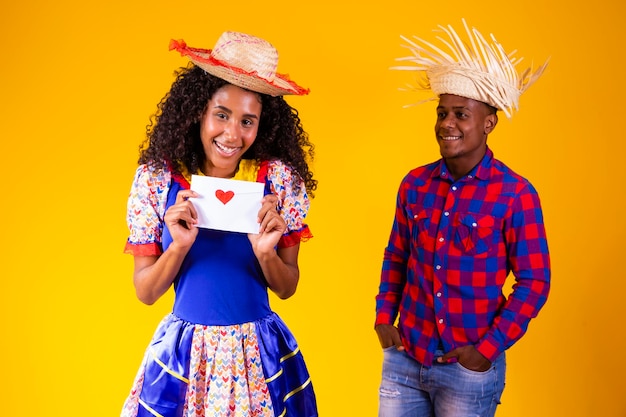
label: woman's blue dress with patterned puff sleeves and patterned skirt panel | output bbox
[122,161,317,417]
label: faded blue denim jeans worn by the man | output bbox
[378,347,506,417]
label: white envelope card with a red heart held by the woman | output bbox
[189,175,265,233]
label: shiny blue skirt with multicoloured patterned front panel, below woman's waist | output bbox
[122,313,318,417]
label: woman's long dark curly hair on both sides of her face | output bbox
[139,63,317,197]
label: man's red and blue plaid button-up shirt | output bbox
[376,149,550,366]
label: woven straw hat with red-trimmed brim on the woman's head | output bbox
[170,32,309,96]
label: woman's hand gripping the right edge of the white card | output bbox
[248,194,287,258]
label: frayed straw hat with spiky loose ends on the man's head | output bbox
[393,19,548,118]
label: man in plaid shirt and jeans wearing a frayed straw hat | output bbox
[375,22,550,417]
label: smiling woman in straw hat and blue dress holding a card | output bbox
[122,32,317,417]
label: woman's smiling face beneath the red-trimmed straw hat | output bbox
[200,84,262,178]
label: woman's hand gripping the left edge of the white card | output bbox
[165,190,200,249]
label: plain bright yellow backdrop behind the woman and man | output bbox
[0,0,626,417]
